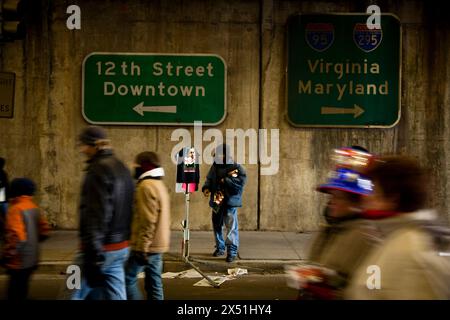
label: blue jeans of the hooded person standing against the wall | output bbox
[212,206,239,257]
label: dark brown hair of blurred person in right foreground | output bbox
[367,156,428,212]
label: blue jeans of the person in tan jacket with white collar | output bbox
[125,253,164,300]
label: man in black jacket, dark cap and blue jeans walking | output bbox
[72,126,134,300]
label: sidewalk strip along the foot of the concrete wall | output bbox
[0,230,313,274]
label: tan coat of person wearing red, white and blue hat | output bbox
[308,219,373,288]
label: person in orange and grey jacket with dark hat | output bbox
[3,178,49,300]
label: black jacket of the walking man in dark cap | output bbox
[79,149,134,262]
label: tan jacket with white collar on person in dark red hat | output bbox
[130,168,170,253]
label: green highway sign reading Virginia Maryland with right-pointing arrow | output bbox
[287,14,401,128]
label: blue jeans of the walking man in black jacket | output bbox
[72,248,129,300]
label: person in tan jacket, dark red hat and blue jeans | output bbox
[125,152,170,300]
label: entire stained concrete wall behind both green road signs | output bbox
[0,0,450,231]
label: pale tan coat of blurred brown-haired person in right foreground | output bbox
[345,212,448,300]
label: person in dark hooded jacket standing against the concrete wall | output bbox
[202,144,247,262]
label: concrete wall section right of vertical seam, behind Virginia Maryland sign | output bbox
[260,1,450,230]
